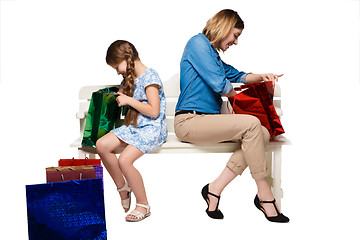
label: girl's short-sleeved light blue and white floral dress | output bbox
[112,68,167,153]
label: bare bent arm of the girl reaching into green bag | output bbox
[116,84,160,118]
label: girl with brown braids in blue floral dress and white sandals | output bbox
[96,40,167,222]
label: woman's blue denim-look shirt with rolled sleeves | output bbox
[175,33,247,114]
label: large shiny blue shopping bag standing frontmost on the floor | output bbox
[26,178,107,240]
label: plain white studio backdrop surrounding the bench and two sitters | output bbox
[0,0,360,240]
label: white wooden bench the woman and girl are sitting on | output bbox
[70,74,290,207]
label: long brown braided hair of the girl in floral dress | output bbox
[106,40,140,127]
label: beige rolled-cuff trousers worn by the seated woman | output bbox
[175,113,270,179]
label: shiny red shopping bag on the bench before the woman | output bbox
[229,82,285,138]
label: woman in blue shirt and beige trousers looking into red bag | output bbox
[175,9,289,222]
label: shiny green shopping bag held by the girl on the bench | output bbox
[81,87,127,147]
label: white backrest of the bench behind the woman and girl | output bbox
[79,74,282,134]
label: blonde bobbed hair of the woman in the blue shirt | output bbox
[202,9,244,50]
